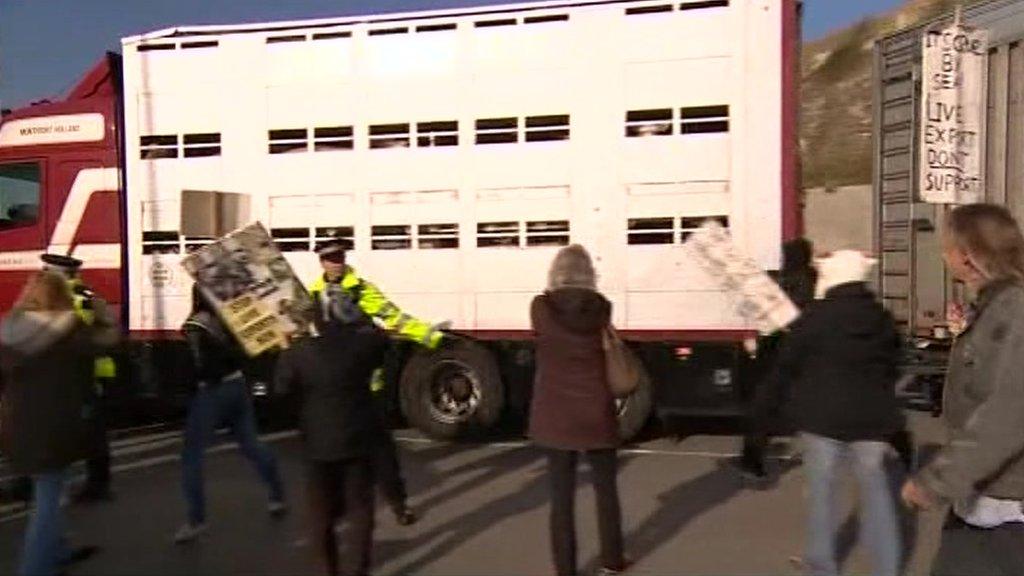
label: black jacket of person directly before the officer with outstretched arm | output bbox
[274,323,388,461]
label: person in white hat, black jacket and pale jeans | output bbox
[770,250,904,576]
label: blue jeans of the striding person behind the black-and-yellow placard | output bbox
[181,374,285,525]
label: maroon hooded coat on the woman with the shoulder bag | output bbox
[529,288,618,450]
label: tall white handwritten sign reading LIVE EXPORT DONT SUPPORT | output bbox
[919,24,988,204]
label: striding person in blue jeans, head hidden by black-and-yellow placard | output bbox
[174,286,287,543]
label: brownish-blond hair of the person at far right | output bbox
[946,204,1024,283]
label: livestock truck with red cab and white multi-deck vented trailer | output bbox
[0,0,801,438]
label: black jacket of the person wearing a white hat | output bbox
[769,282,903,442]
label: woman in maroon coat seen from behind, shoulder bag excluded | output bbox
[529,245,626,576]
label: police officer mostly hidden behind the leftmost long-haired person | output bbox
[41,254,118,502]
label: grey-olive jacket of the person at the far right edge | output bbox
[919,282,1024,500]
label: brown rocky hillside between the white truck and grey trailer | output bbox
[800,0,978,189]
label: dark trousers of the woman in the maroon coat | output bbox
[546,449,624,576]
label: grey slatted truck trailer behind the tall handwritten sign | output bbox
[872,0,1024,413]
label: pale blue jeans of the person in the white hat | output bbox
[801,433,901,576]
